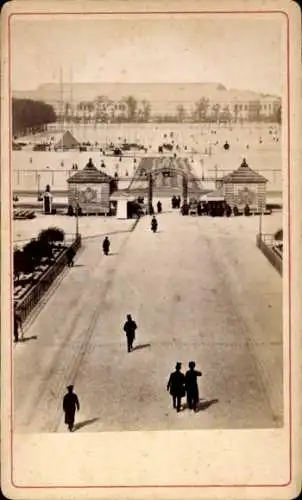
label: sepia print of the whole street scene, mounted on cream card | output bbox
[1,2,298,498]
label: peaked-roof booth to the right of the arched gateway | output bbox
[219,158,268,211]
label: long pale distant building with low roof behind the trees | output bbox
[13,83,281,121]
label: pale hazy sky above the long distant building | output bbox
[11,16,284,95]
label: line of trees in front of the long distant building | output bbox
[12,96,282,135]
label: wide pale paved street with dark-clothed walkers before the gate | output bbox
[13,212,283,432]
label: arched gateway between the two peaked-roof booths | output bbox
[128,156,200,213]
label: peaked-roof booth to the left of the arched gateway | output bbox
[67,159,112,215]
